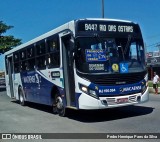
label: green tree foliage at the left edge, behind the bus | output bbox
[0,21,21,54]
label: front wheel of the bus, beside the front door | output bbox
[56,96,66,117]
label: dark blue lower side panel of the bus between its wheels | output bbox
[21,71,64,105]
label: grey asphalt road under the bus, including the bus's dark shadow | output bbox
[0,91,160,142]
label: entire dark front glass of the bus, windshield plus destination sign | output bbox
[75,20,146,74]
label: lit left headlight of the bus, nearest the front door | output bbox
[79,84,98,99]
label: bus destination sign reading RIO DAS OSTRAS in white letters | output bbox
[77,20,138,33]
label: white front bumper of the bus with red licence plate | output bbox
[79,88,149,110]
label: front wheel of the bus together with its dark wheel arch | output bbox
[51,86,66,117]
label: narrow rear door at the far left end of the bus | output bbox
[7,56,15,98]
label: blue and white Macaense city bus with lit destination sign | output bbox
[5,19,149,116]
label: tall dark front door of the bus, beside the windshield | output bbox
[59,33,76,107]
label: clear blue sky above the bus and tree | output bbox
[0,0,160,70]
